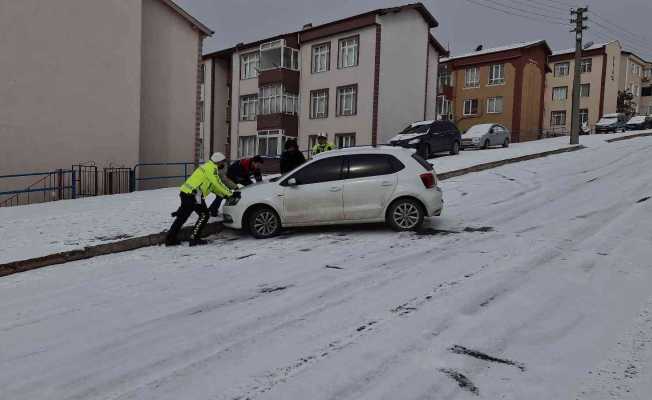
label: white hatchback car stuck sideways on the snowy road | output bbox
[224,146,443,238]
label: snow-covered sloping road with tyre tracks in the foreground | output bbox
[0,138,652,400]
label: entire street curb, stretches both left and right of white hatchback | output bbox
[0,144,584,277]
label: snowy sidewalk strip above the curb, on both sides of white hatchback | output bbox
[0,132,640,264]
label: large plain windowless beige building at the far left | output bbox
[0,0,212,181]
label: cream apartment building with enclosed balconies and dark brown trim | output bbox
[204,3,446,159]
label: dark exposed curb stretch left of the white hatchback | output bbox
[0,222,224,277]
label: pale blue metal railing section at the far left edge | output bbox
[0,169,77,207]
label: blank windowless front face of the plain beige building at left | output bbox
[0,0,141,177]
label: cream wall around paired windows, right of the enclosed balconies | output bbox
[299,26,376,150]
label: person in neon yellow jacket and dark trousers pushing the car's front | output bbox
[165,153,240,246]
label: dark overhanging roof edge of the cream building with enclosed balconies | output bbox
[204,3,440,58]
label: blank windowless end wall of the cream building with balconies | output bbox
[378,10,429,143]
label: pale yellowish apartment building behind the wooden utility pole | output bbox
[544,41,623,134]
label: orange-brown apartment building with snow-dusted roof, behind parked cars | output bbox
[437,40,551,142]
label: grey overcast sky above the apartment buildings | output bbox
[176,0,652,61]
